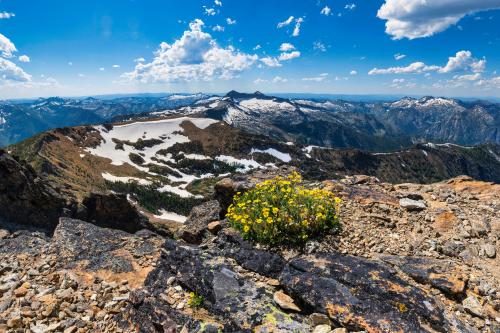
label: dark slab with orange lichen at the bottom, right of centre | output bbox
[280,253,450,332]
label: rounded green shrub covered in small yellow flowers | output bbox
[226,173,341,246]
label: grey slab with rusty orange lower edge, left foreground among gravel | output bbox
[50,218,162,286]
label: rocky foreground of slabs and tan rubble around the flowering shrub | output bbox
[0,160,500,333]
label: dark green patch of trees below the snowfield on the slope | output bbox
[106,181,204,215]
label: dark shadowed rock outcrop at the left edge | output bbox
[0,150,70,229]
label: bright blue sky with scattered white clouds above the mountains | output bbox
[0,0,500,98]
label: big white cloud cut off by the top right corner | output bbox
[377,0,500,39]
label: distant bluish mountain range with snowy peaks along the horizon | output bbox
[0,91,500,151]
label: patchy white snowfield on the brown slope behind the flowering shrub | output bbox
[87,115,292,198]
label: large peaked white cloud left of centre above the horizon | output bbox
[122,19,258,83]
